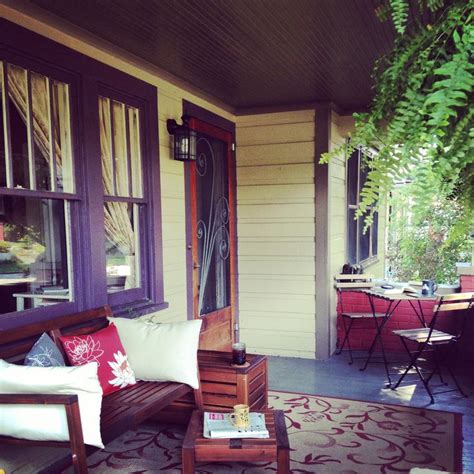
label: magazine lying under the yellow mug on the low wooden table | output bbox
[203,412,270,438]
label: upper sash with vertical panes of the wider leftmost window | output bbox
[0,58,75,194]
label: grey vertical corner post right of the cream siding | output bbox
[314,103,331,359]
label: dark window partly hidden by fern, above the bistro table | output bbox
[347,150,378,264]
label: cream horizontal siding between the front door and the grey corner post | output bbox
[236,110,315,358]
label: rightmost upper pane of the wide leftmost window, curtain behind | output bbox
[53,81,75,193]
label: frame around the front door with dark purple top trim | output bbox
[183,100,239,340]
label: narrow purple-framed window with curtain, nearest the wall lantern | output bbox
[99,97,146,293]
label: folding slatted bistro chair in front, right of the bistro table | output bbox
[392,293,474,403]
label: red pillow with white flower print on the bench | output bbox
[60,323,136,395]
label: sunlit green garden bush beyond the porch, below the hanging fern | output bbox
[387,185,473,283]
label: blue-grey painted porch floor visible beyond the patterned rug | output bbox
[268,353,474,473]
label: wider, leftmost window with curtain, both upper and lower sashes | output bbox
[0,61,75,314]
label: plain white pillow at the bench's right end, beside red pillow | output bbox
[110,318,202,388]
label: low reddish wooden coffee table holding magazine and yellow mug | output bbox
[182,410,290,474]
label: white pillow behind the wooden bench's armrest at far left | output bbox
[0,360,104,448]
